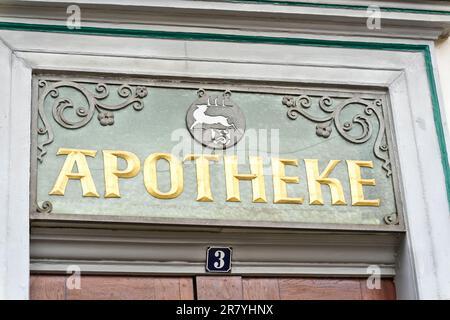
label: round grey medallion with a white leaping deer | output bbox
[186,89,245,149]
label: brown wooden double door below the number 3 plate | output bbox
[30,275,395,300]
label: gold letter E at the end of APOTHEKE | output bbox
[347,160,380,207]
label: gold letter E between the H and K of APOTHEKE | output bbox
[272,158,303,204]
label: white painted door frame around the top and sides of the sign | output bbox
[0,23,450,298]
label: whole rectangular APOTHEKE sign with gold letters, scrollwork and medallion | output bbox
[32,76,400,228]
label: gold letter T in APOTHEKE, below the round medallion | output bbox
[184,154,219,202]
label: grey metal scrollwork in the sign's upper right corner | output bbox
[282,95,392,177]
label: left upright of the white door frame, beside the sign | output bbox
[0,43,31,299]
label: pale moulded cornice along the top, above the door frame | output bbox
[0,0,450,40]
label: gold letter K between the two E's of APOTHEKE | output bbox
[304,159,346,205]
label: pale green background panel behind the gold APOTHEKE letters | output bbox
[37,80,396,225]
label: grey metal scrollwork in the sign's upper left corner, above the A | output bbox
[37,80,148,162]
